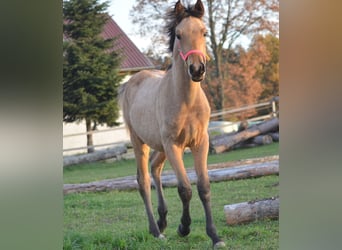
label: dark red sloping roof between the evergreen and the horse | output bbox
[102,17,155,72]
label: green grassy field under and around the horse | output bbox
[64,143,279,250]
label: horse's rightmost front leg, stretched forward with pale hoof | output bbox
[191,134,225,248]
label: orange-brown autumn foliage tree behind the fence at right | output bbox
[203,34,279,119]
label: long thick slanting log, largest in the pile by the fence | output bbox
[210,117,279,153]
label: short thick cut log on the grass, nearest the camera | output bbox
[224,197,279,225]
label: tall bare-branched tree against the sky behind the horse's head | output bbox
[131,0,279,110]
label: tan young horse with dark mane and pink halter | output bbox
[119,0,225,248]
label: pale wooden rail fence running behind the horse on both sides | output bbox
[63,97,279,152]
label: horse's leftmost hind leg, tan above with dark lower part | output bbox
[131,136,163,237]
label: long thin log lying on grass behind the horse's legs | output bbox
[63,159,279,194]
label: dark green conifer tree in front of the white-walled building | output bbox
[63,0,123,153]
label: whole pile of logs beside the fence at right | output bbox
[209,117,279,154]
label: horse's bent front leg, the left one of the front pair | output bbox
[165,144,192,237]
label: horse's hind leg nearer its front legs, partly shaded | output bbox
[150,151,167,233]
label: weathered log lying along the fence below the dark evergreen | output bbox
[63,145,127,167]
